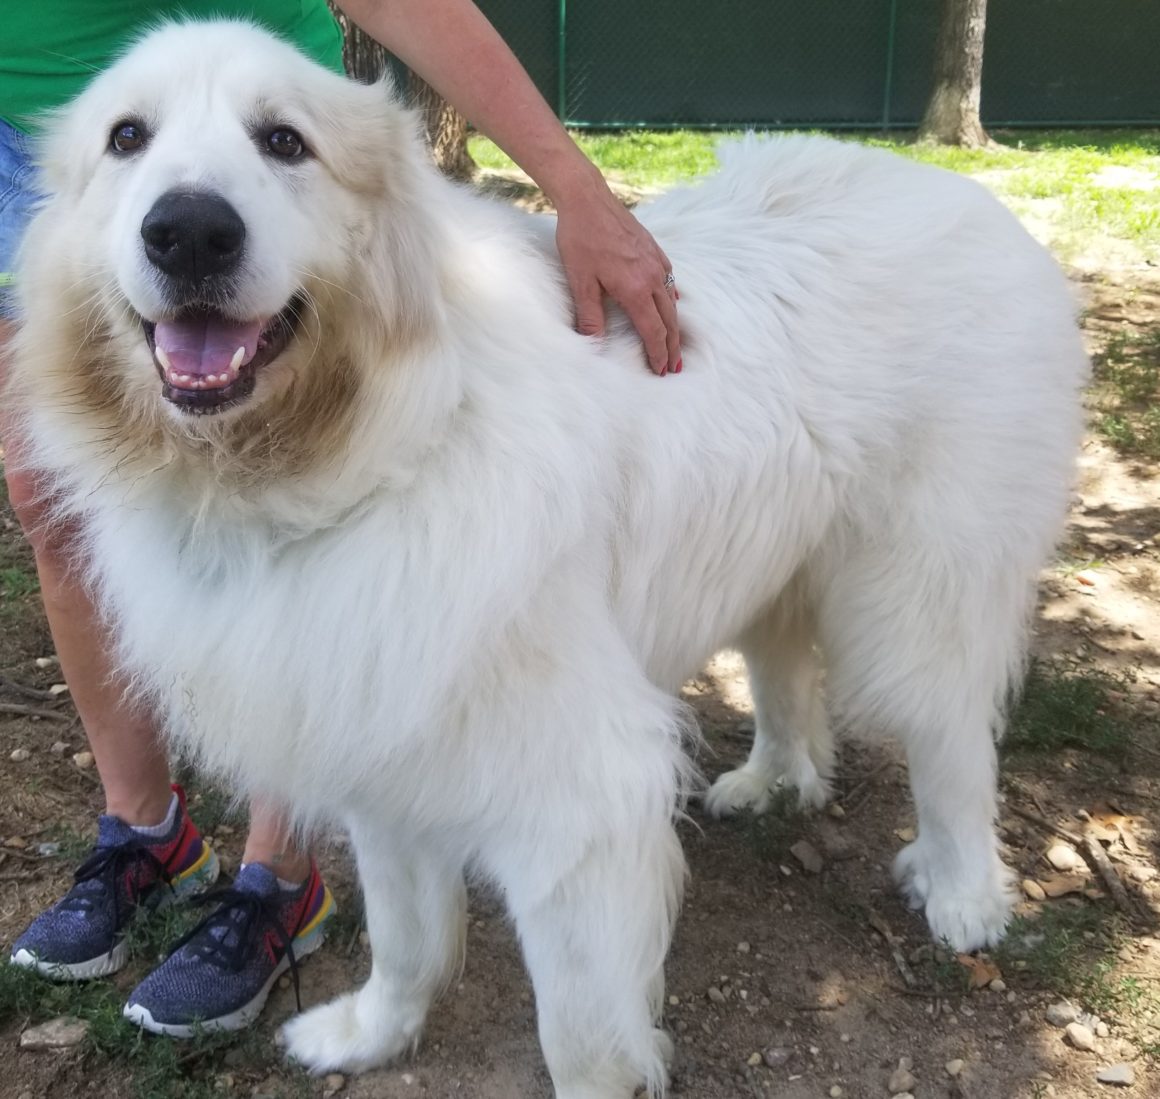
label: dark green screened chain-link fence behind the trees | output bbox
[479,0,1160,129]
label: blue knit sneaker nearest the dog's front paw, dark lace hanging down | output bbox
[124,862,336,1037]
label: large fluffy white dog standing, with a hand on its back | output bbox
[8,22,1086,1099]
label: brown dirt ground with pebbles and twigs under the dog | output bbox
[0,197,1160,1099]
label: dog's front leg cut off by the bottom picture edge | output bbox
[505,807,684,1099]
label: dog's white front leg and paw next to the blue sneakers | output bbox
[283,826,466,1072]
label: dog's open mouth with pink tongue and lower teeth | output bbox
[142,295,302,415]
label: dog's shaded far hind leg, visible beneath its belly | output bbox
[705,591,834,817]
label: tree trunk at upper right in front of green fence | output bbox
[919,0,991,149]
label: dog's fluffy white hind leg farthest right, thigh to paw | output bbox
[822,533,1029,950]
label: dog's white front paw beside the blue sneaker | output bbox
[282,989,422,1073]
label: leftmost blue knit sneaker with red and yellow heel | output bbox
[12,786,218,981]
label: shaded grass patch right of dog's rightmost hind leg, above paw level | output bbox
[1002,659,1132,759]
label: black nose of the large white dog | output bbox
[142,190,246,282]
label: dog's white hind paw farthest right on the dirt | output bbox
[894,839,1015,954]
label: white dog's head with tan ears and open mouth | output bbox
[21,21,436,434]
